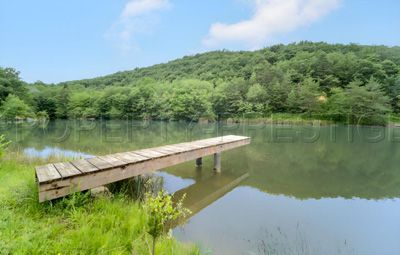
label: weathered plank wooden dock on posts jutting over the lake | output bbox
[36,135,250,202]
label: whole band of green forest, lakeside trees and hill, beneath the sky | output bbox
[0,42,400,122]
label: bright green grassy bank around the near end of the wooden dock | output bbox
[0,154,199,254]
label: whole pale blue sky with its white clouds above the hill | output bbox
[0,0,400,82]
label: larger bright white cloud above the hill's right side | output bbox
[203,0,341,48]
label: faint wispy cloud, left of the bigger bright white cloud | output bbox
[106,0,171,52]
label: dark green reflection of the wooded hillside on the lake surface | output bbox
[0,121,400,199]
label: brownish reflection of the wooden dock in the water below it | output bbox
[174,173,249,222]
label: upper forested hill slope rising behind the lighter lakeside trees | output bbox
[61,42,400,86]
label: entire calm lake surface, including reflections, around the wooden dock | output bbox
[0,121,400,255]
